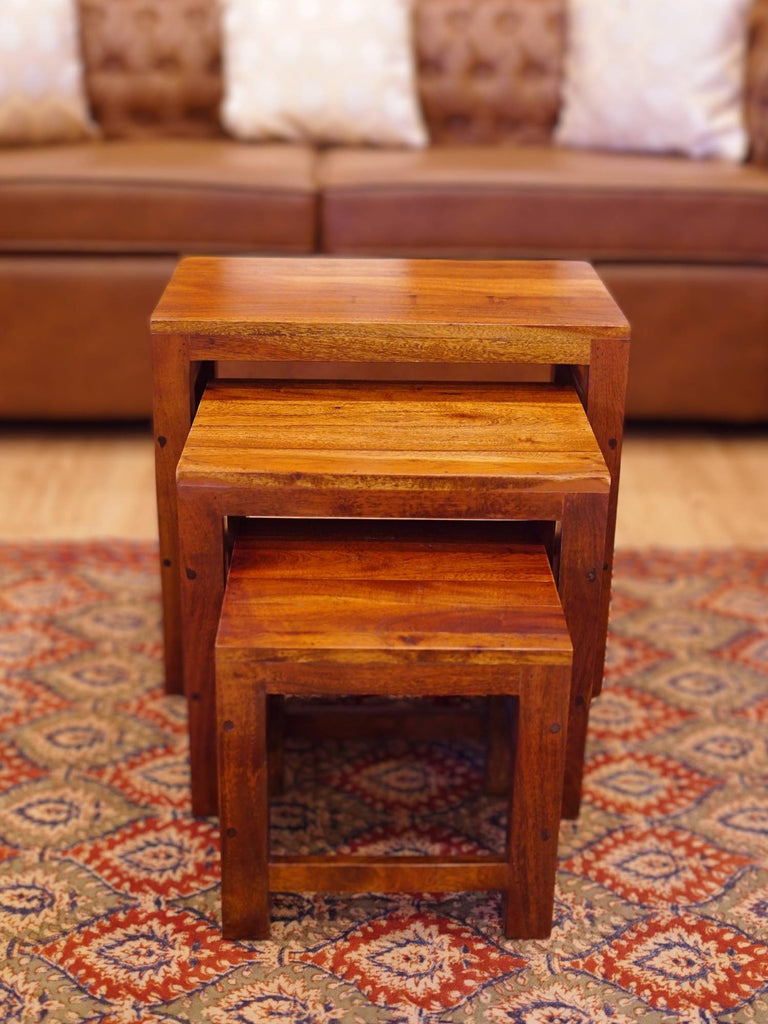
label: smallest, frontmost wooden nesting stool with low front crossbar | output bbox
[216,522,571,939]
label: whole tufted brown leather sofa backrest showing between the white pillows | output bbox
[78,0,768,163]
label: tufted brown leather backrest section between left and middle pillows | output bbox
[79,0,221,138]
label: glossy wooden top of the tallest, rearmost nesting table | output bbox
[152,257,629,361]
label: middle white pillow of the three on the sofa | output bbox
[221,0,427,146]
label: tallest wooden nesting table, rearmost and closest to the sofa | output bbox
[152,257,629,806]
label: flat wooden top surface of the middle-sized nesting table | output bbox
[178,381,610,483]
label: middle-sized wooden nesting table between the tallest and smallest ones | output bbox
[177,381,610,816]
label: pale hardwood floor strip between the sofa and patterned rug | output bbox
[0,417,768,548]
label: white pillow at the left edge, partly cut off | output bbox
[0,0,95,144]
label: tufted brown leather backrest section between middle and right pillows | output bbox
[416,0,564,144]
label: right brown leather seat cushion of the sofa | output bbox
[318,146,768,263]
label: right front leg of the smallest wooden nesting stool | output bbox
[504,666,570,939]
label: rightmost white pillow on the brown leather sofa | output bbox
[555,0,751,161]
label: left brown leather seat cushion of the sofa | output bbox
[0,139,316,253]
